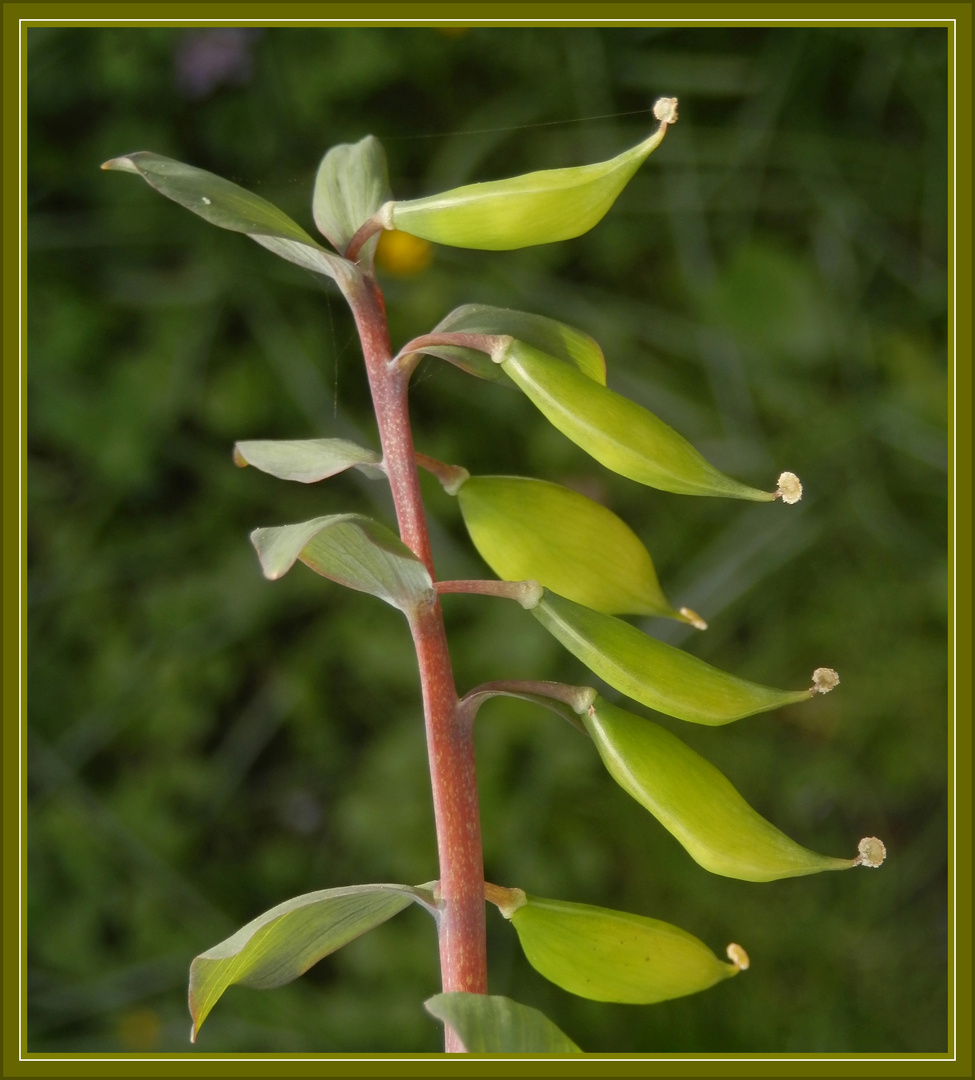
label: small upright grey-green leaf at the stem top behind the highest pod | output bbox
[312,135,392,262]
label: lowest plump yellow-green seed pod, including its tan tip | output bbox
[510,895,747,1005]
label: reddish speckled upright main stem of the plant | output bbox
[346,267,487,1053]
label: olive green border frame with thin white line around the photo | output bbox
[2,2,973,1077]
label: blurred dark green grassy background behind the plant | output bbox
[26,27,949,1053]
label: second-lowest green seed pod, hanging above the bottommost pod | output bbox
[583,698,862,881]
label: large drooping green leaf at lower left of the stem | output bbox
[190,885,434,1042]
